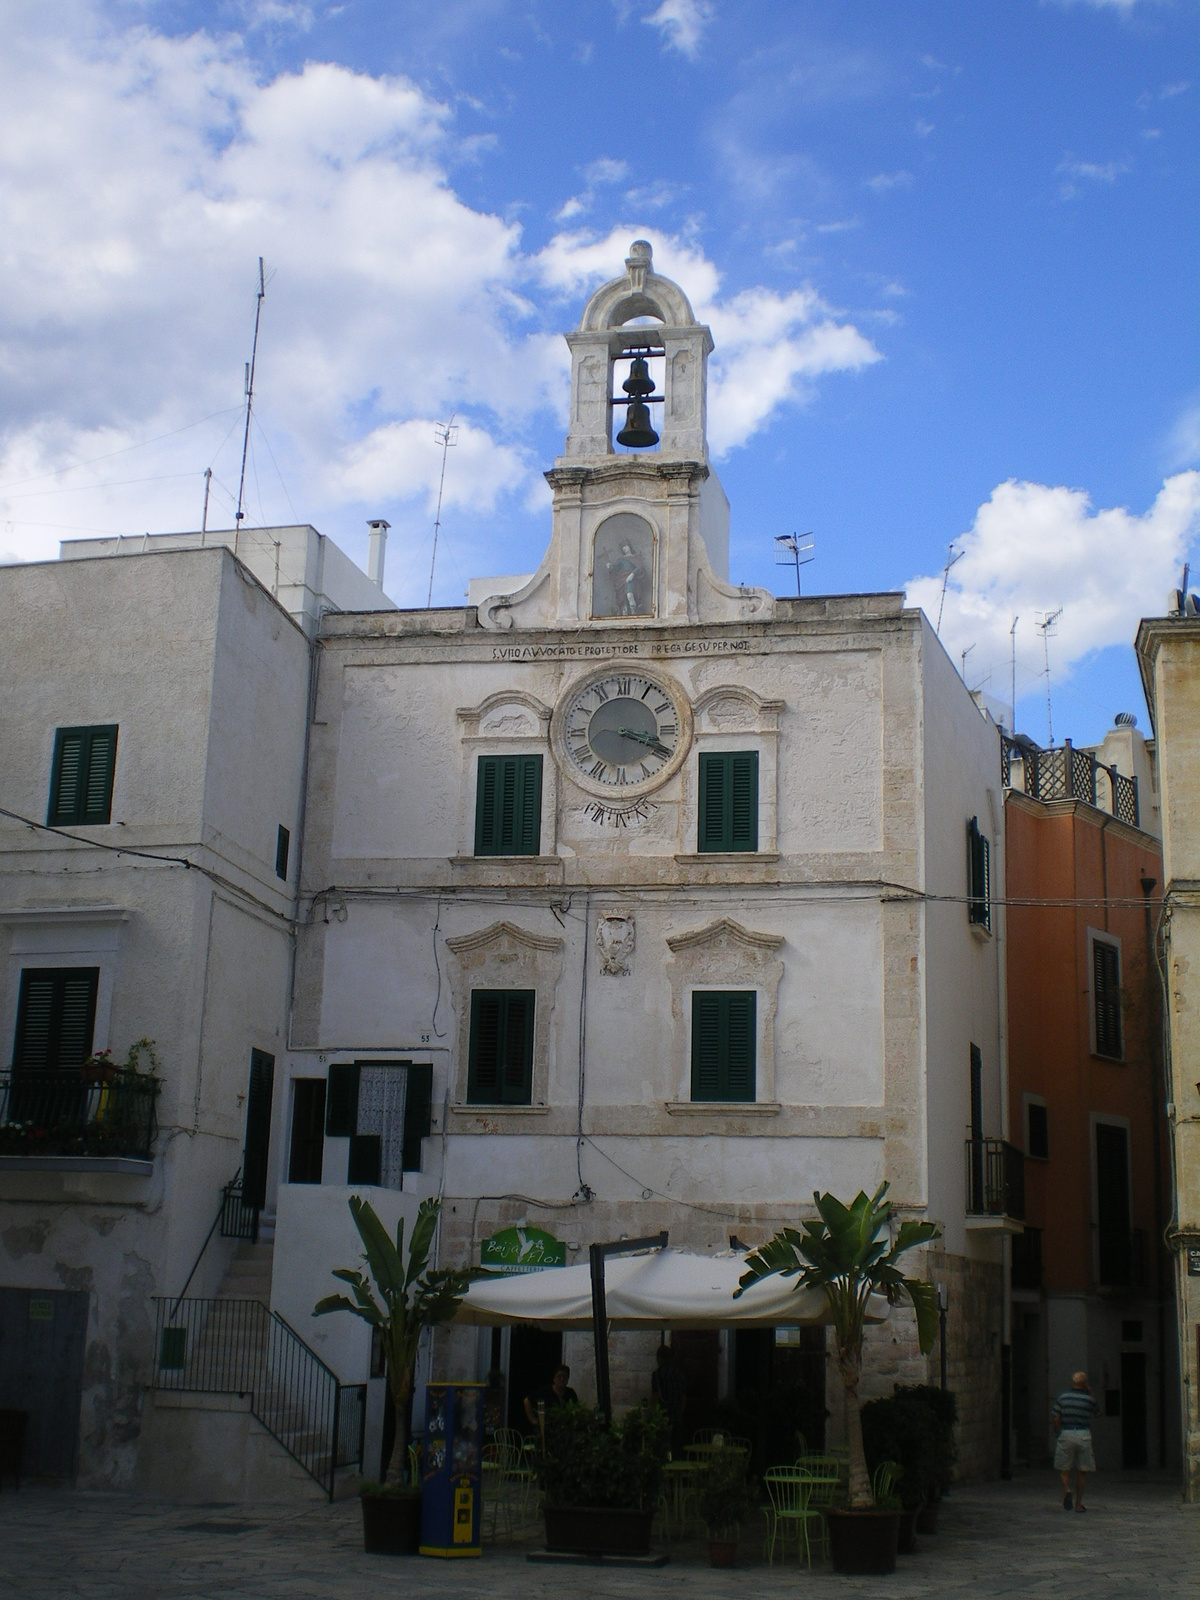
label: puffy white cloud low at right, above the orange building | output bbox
[907,472,1200,693]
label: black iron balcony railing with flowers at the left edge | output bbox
[0,1070,162,1160]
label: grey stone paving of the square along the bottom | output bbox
[0,1474,1200,1600]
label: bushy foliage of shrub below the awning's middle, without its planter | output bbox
[538,1405,670,1510]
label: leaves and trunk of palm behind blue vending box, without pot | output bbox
[312,1195,474,1488]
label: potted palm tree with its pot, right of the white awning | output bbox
[734,1184,941,1573]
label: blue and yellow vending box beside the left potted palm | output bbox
[421,1384,486,1555]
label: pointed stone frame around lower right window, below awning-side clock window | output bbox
[666,917,787,1117]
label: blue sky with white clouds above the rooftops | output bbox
[0,0,1200,742]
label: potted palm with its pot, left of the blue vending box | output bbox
[312,1195,474,1555]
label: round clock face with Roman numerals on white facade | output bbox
[562,672,686,794]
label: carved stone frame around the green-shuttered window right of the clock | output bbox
[678,683,786,862]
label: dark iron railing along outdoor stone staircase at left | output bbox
[154,1299,366,1499]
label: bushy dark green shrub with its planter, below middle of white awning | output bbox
[538,1405,670,1555]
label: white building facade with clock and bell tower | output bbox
[280,242,1019,1475]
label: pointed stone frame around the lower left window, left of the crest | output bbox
[446,920,566,1117]
